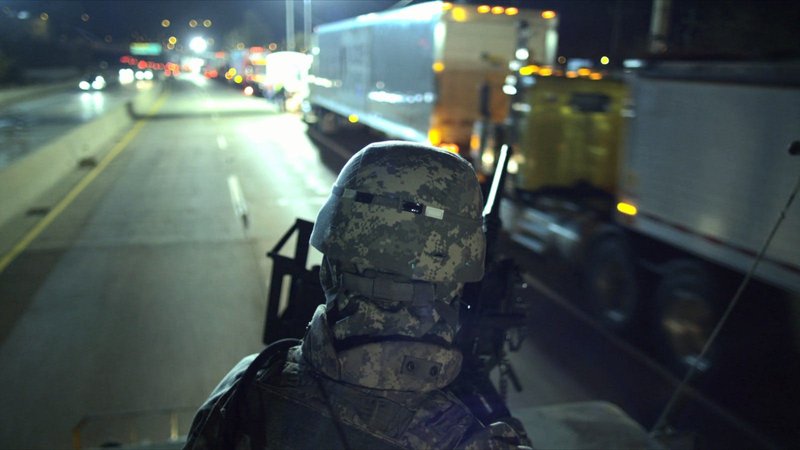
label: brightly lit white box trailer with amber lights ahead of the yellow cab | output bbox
[304,2,558,156]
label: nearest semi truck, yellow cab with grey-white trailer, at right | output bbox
[471,61,800,372]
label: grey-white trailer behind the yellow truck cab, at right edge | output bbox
[619,62,800,293]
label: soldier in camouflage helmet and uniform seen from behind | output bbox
[185,141,527,449]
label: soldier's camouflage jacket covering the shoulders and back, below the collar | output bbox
[185,306,530,450]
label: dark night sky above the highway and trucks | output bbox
[0,0,800,61]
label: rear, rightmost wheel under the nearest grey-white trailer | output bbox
[654,259,719,374]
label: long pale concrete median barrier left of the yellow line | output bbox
[0,83,163,227]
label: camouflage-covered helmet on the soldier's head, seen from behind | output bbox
[311,141,485,282]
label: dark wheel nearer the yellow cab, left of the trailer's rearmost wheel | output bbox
[584,235,638,332]
